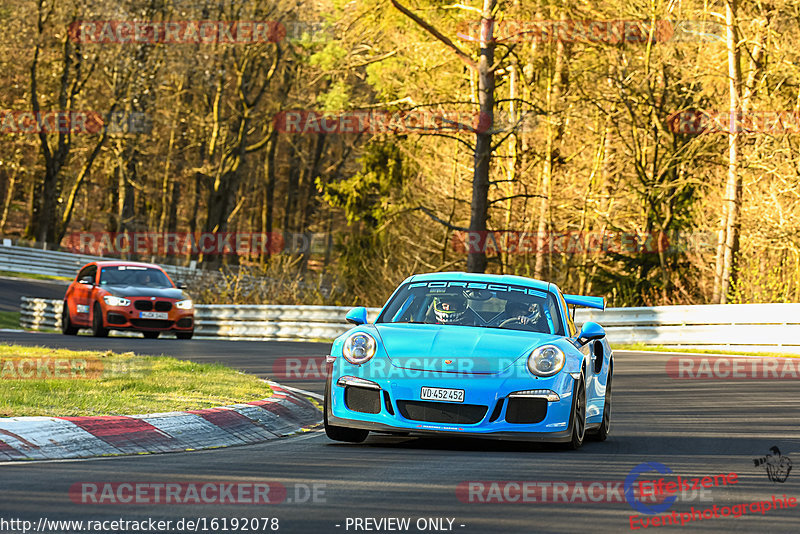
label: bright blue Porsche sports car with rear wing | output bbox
[324,273,614,449]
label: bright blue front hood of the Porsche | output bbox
[375,323,558,374]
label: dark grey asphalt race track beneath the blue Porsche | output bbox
[0,333,800,533]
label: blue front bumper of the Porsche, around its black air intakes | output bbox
[326,364,577,442]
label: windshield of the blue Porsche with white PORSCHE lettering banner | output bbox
[375,280,564,336]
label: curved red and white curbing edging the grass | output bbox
[0,383,322,461]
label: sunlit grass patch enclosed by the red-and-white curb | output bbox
[0,344,272,417]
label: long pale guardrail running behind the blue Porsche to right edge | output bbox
[14,297,800,353]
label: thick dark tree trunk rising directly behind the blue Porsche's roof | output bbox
[467,0,497,273]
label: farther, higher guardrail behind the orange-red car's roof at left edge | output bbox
[0,244,196,279]
